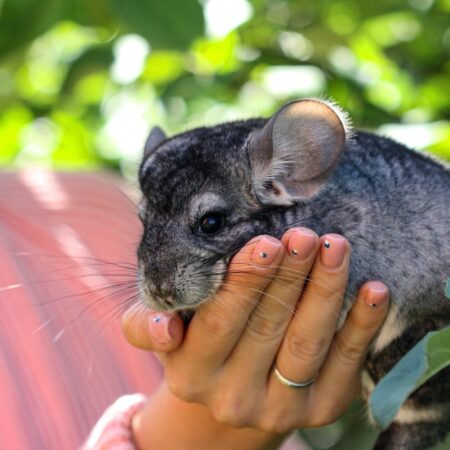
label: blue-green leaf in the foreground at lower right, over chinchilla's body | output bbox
[369,326,450,429]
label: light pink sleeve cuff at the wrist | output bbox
[80,394,147,450]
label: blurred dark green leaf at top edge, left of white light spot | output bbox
[109,0,204,49]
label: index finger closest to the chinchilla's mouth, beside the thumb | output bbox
[165,236,284,379]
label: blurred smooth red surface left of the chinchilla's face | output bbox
[0,170,161,450]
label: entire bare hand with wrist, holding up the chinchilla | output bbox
[123,228,388,450]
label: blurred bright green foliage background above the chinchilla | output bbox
[0,0,450,176]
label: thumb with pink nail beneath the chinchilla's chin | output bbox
[122,303,184,353]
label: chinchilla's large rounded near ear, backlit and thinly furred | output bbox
[248,99,348,206]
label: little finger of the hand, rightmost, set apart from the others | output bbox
[315,281,389,411]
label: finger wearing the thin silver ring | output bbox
[272,234,350,390]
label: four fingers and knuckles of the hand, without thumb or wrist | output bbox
[155,229,387,432]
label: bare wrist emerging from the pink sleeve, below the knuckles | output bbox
[133,382,284,450]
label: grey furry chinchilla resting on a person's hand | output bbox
[138,99,450,450]
